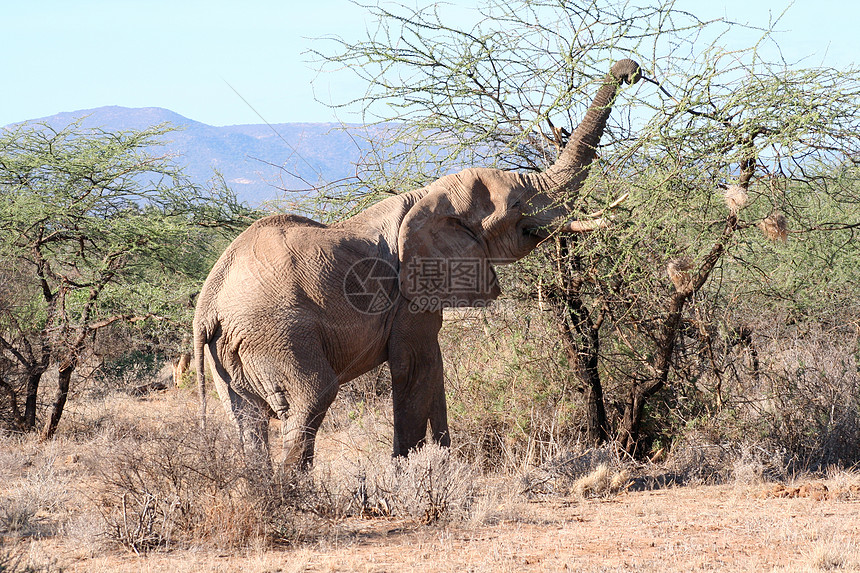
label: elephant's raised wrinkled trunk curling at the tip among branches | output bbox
[531,59,641,195]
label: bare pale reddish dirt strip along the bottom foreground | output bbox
[13,478,860,573]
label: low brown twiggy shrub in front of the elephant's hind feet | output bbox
[99,421,322,552]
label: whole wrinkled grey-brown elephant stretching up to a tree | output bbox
[194,60,639,467]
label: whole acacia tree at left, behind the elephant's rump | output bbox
[0,122,252,438]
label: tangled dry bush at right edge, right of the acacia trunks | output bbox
[660,314,860,474]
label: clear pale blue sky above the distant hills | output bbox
[0,0,860,125]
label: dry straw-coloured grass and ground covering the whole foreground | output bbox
[0,389,860,573]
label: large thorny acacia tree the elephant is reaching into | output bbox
[321,1,860,454]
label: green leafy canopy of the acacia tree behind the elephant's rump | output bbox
[0,120,246,320]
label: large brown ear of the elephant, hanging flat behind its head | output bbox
[397,190,501,311]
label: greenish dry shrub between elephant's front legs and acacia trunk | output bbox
[440,301,584,473]
